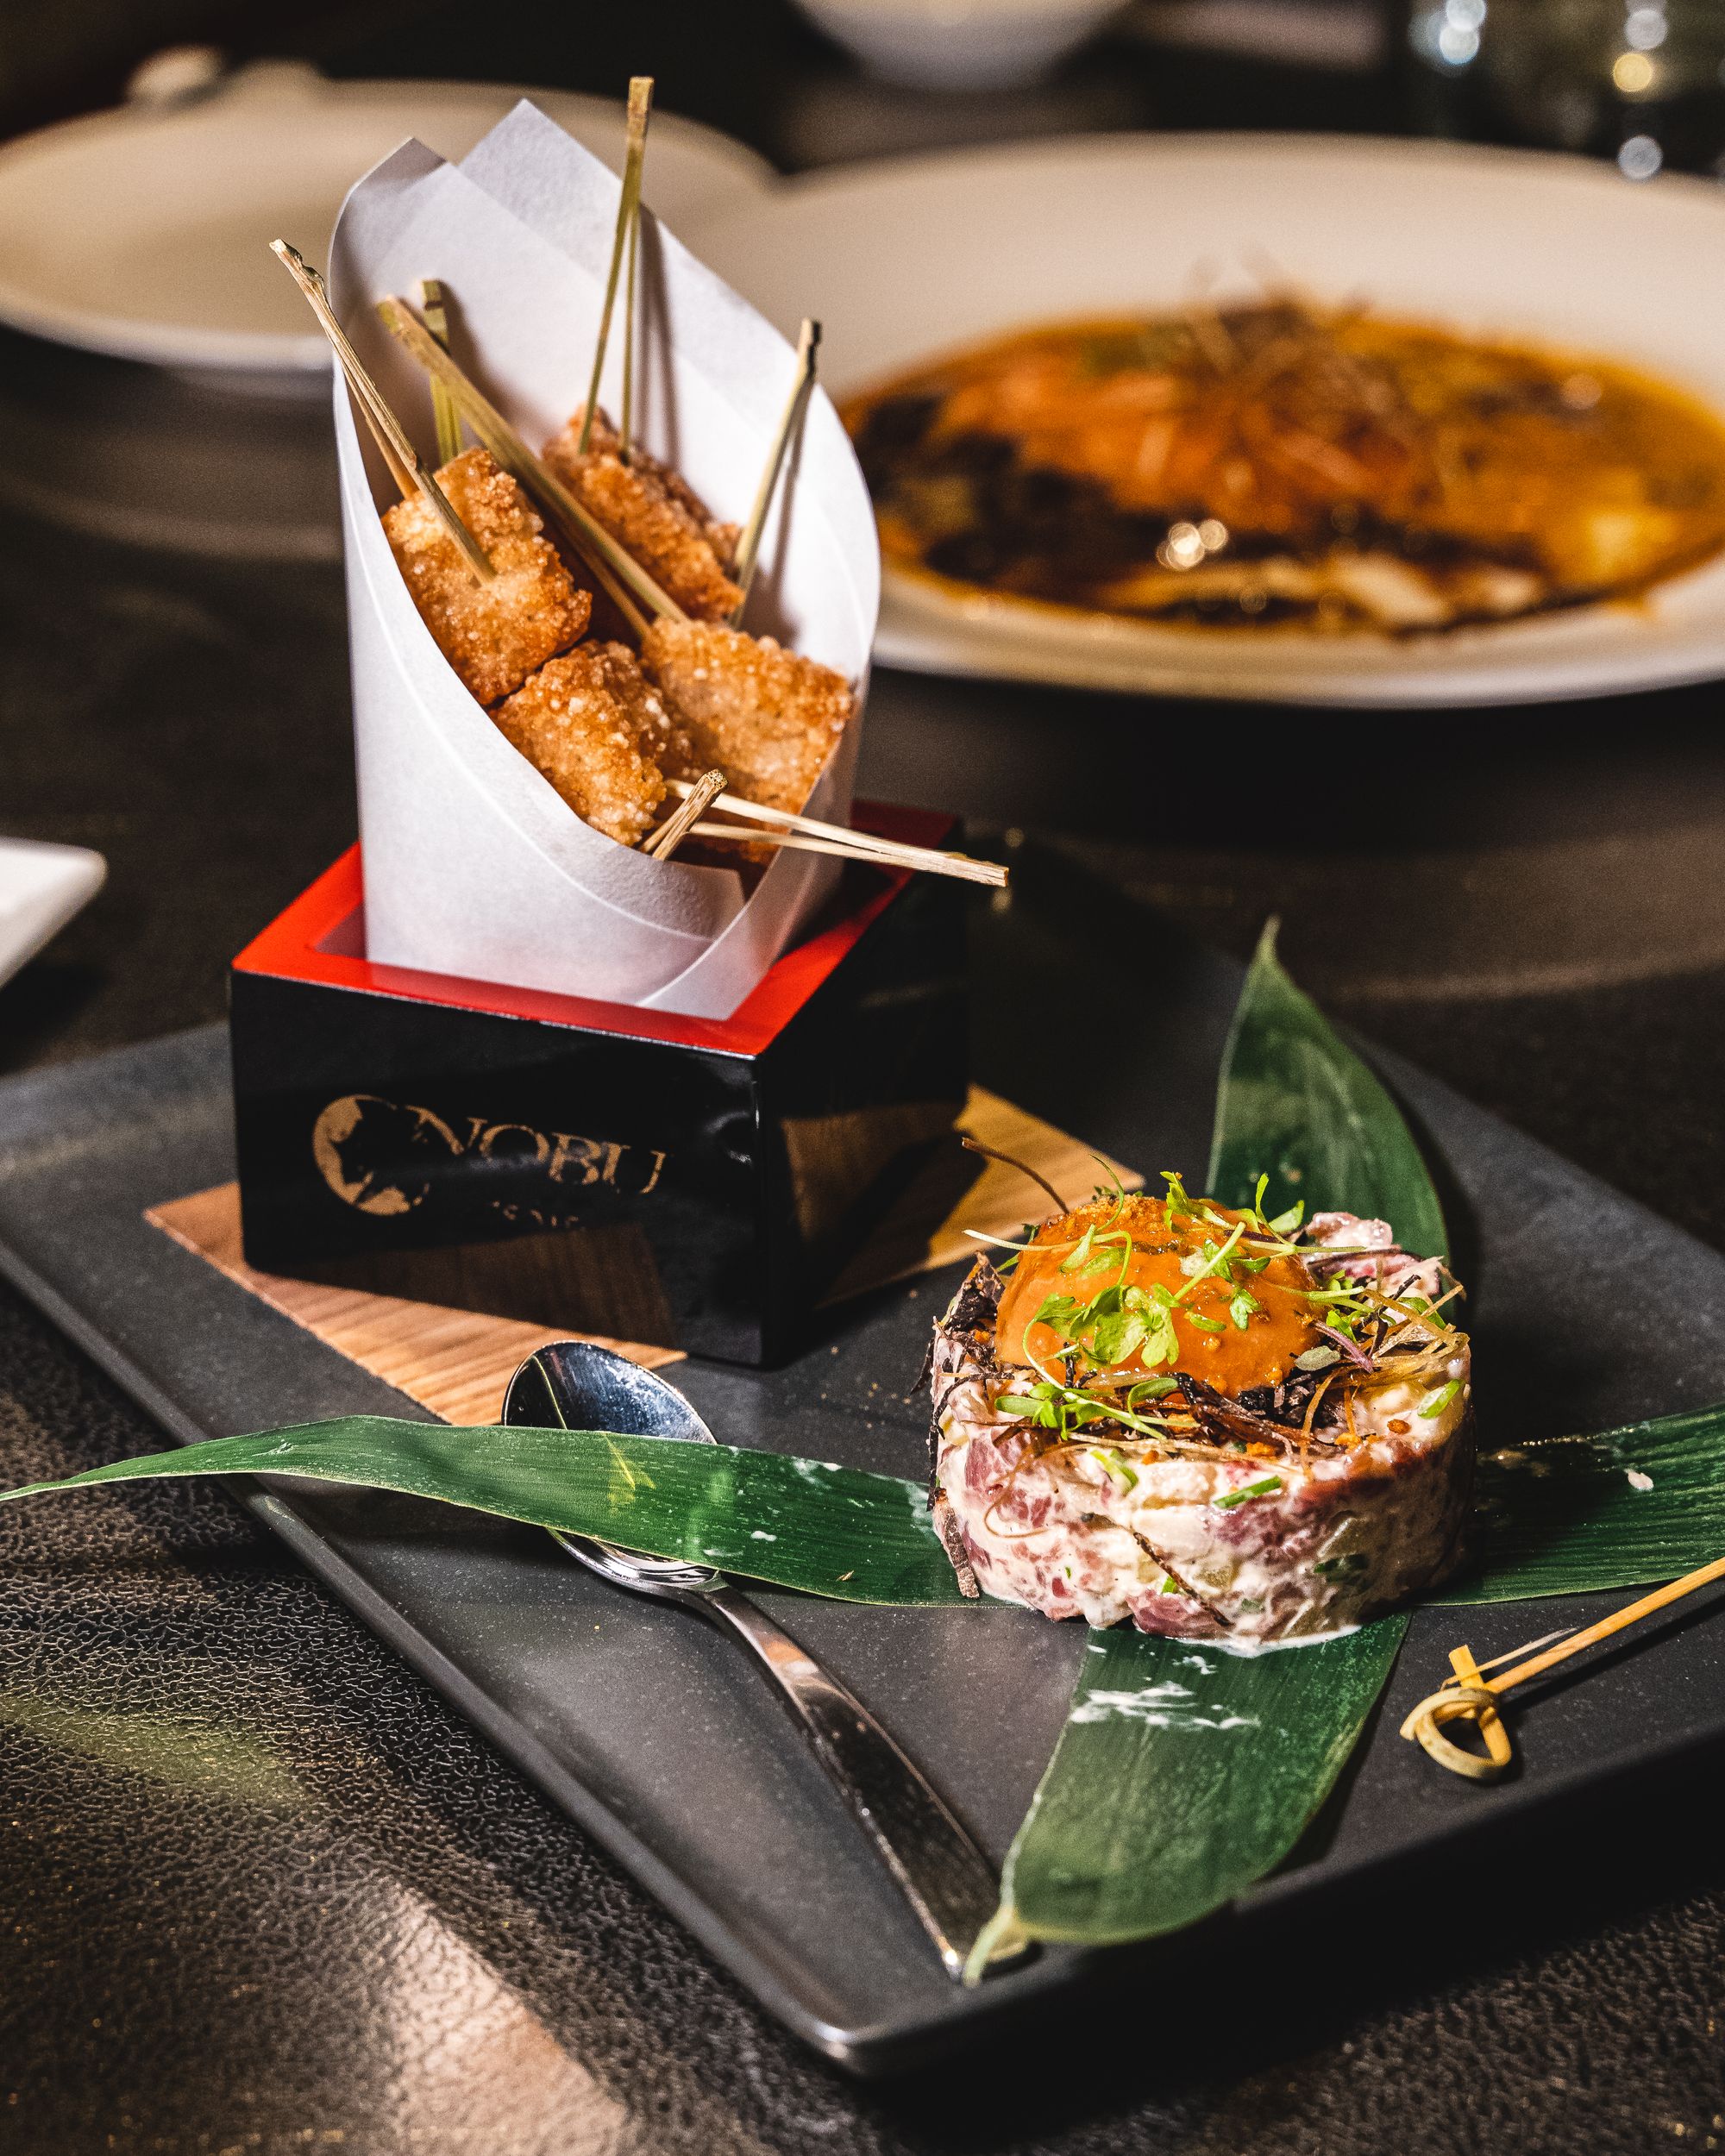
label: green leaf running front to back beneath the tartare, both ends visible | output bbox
[990,921,1449,1975]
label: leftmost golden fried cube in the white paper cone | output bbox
[384,448,593,705]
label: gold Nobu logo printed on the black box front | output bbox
[310,1094,667,1220]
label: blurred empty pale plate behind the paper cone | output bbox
[0,63,775,375]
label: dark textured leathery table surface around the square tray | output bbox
[0,8,1725,2156]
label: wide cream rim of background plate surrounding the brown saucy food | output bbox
[681,136,1725,705]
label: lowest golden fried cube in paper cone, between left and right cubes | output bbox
[494,645,690,845]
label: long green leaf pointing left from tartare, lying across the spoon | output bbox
[0,1414,970,1608]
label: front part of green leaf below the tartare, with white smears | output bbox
[1000,1617,1408,1947]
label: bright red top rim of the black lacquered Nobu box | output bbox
[233,802,953,1056]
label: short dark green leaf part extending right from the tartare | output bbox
[1432,1406,1725,1602]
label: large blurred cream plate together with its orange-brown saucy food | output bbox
[686,136,1725,705]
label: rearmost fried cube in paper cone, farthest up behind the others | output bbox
[546,412,742,621]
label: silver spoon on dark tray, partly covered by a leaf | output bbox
[503,1341,999,1977]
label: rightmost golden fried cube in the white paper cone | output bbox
[641,619,856,813]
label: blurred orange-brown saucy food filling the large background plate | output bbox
[845,300,1725,634]
